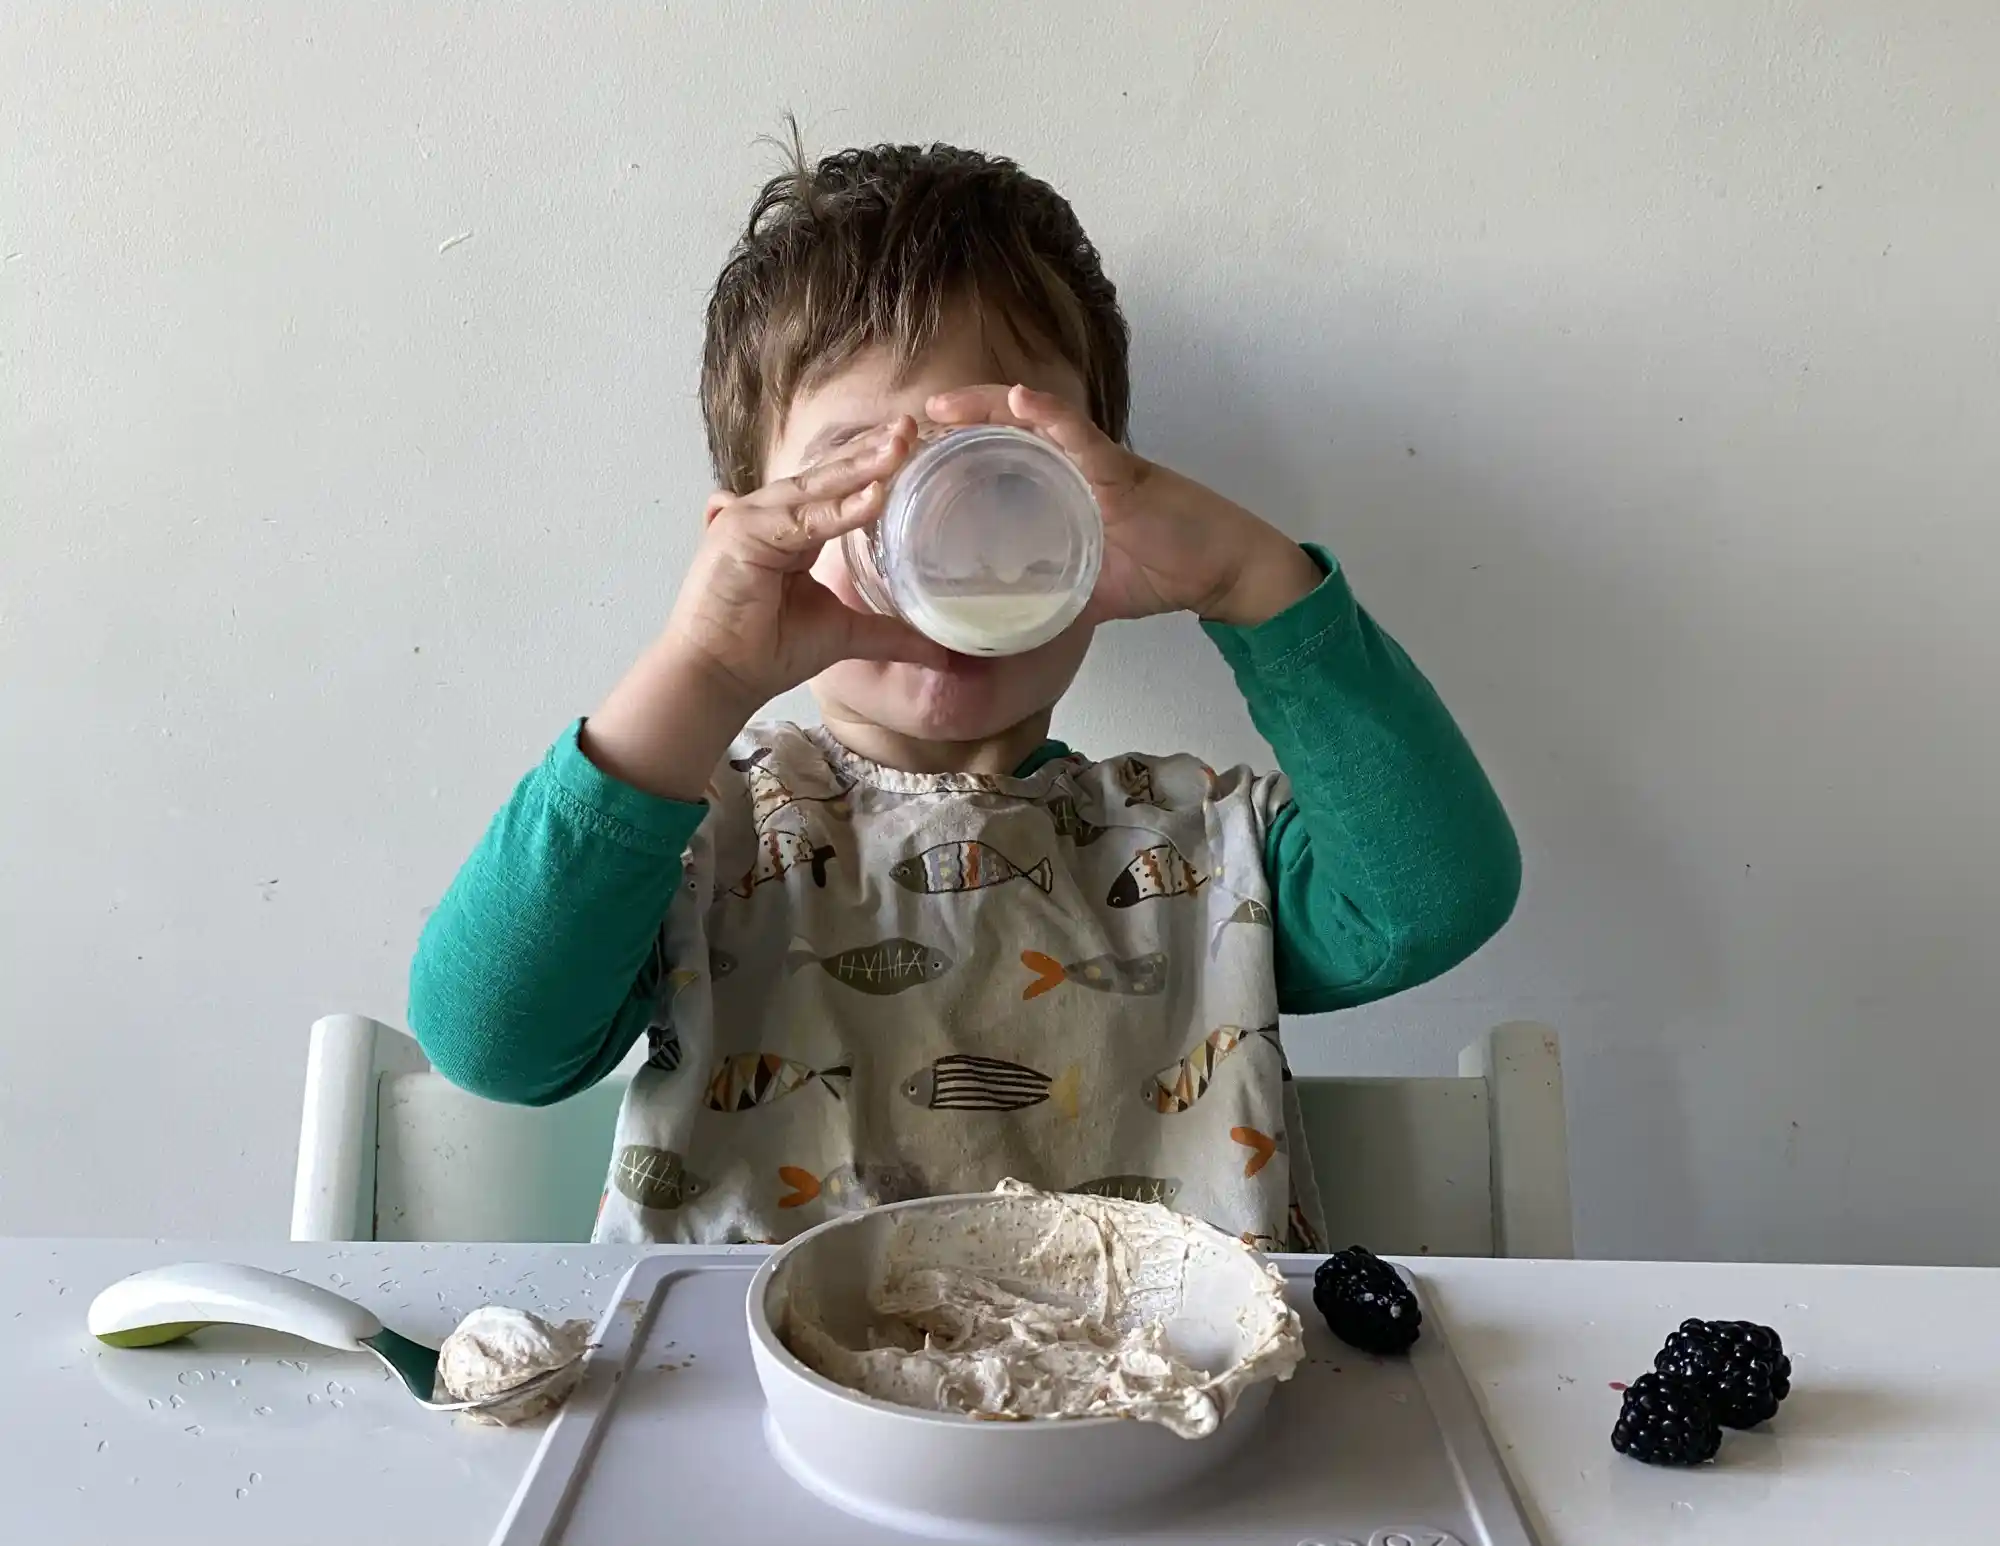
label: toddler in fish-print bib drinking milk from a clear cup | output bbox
[410,146,1520,1250]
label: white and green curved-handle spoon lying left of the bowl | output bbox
[90,1262,580,1414]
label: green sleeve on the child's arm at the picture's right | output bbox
[1206,548,1520,1014]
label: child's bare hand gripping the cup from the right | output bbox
[926,386,1322,626]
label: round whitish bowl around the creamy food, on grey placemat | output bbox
[748,1192,1296,1536]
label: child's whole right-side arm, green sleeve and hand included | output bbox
[930,386,1520,1012]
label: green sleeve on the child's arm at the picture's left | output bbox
[410,724,706,1106]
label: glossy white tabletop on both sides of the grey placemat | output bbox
[0,1240,2000,1546]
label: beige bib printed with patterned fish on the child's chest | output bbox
[596,724,1322,1250]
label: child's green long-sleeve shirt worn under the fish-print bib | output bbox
[410,550,1520,1104]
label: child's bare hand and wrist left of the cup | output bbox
[582,416,946,800]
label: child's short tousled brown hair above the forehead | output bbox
[702,124,1132,494]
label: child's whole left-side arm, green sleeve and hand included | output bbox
[410,418,940,1104]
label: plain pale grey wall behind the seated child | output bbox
[0,0,2000,1262]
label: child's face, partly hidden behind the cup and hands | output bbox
[764,312,1092,742]
